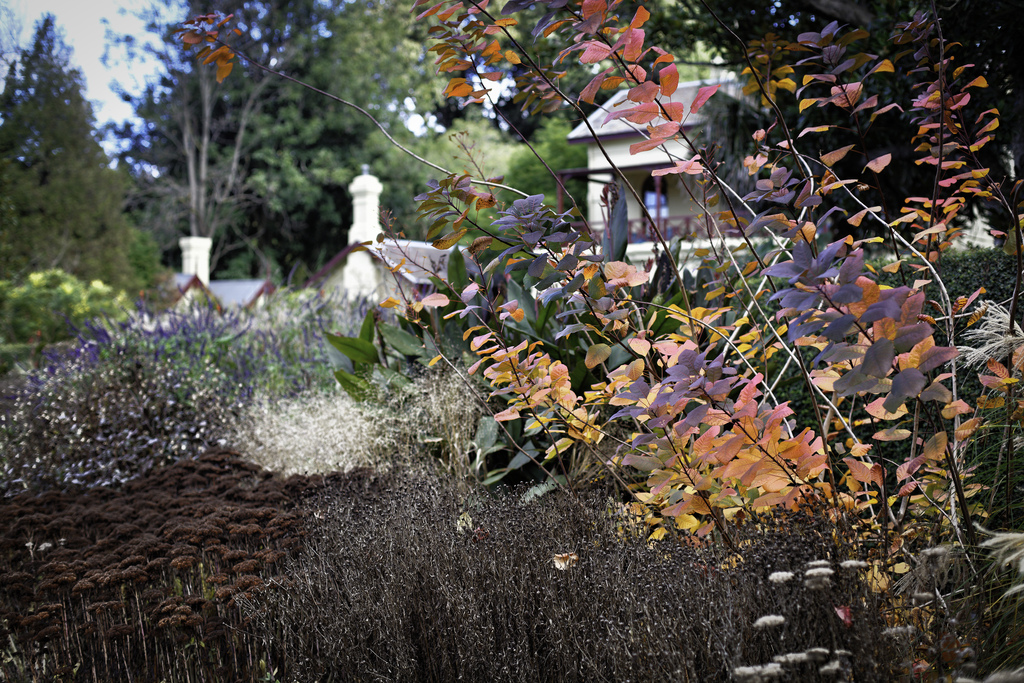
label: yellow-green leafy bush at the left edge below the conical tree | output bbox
[0,269,129,346]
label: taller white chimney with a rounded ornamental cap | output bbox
[342,164,384,296]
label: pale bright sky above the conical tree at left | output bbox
[0,0,155,134]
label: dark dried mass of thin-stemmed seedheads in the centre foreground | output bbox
[240,476,909,681]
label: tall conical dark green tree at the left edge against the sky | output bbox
[0,15,148,289]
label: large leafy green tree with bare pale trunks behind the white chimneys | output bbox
[118,0,444,276]
